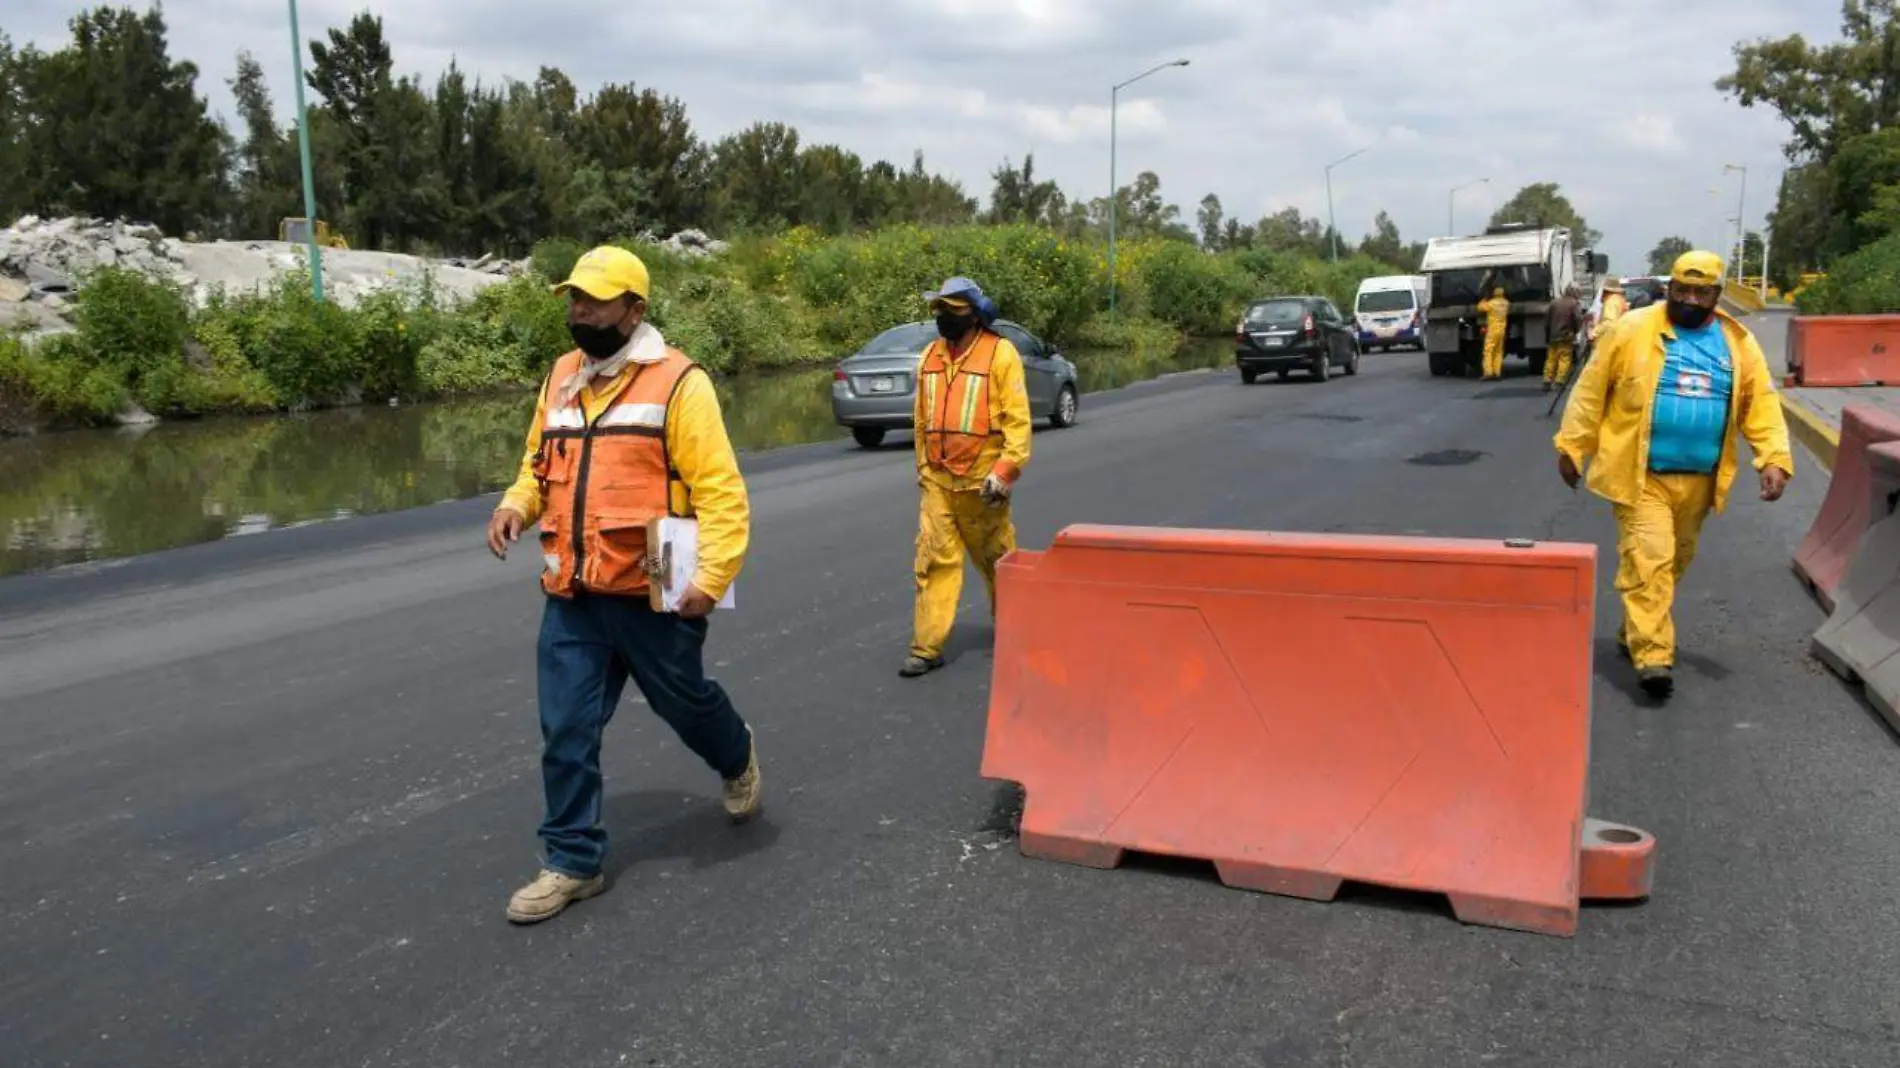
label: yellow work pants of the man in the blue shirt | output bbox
[1617,473,1716,669]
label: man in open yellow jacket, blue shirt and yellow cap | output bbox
[1556,251,1794,699]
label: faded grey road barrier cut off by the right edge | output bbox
[1813,441,1900,730]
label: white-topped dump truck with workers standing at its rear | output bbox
[1419,222,1607,374]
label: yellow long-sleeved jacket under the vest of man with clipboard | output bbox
[500,365,752,601]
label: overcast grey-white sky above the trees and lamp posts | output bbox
[0,0,1839,272]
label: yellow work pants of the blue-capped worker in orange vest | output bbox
[910,481,1017,659]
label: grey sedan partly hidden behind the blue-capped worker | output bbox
[832,319,1081,448]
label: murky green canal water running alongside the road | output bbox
[0,342,1233,576]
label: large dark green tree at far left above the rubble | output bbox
[12,8,230,232]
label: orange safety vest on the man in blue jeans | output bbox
[534,348,695,597]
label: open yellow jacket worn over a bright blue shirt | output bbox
[1556,304,1794,511]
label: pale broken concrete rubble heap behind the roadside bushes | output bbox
[0,215,726,333]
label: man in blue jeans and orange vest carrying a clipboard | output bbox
[488,247,760,924]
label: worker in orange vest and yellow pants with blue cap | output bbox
[899,277,1030,678]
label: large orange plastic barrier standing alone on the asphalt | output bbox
[982,526,1655,935]
